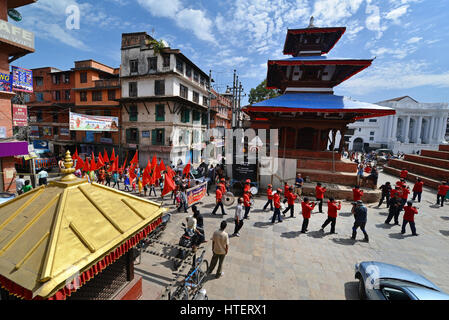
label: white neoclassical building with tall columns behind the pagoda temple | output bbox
[346,96,449,153]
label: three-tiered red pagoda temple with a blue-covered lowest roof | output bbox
[244,18,395,185]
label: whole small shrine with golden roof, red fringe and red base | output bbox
[0,151,166,300]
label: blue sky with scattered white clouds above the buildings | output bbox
[9,0,449,102]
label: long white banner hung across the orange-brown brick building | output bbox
[70,112,118,132]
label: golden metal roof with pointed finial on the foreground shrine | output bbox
[0,153,166,298]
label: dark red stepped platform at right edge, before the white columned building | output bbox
[384,145,449,189]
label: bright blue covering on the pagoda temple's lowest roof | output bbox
[248,93,394,112]
